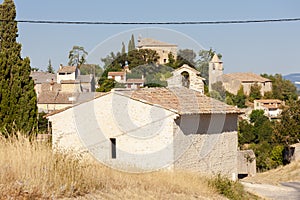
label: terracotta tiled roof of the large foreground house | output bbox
[115,87,243,115]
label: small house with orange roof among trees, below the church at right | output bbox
[254,99,285,119]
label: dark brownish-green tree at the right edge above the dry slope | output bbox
[274,100,300,145]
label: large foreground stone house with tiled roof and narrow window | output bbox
[47,87,241,178]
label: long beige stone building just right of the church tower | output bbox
[217,72,272,95]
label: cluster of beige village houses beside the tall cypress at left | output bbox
[30,65,95,113]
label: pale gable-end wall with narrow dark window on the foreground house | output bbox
[49,93,177,172]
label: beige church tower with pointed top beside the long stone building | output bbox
[208,54,224,91]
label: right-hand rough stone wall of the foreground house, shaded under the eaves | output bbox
[174,115,238,177]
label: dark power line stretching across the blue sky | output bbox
[1,18,300,25]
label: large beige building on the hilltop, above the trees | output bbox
[137,38,177,64]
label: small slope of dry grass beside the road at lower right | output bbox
[243,160,300,184]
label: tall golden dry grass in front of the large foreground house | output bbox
[0,137,227,199]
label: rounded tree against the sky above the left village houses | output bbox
[68,46,88,68]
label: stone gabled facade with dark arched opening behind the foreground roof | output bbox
[167,64,205,94]
